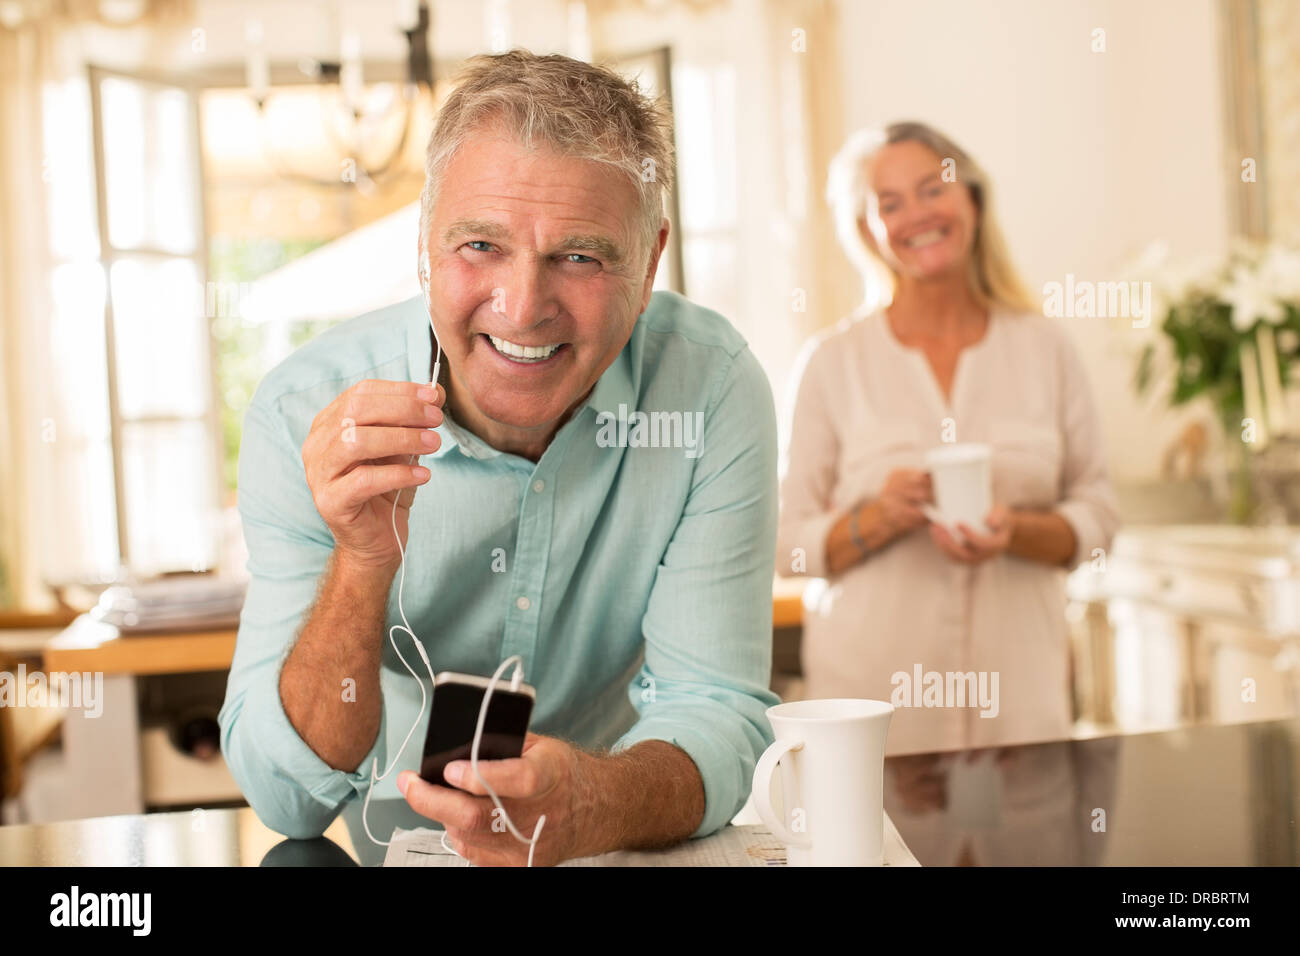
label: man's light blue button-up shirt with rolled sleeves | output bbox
[220,293,777,838]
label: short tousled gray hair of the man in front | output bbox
[420,49,673,269]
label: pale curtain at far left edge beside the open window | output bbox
[0,0,194,611]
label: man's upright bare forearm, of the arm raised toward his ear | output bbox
[280,553,393,773]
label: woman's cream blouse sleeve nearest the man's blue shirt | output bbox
[776,338,840,578]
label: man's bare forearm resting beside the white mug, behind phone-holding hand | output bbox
[579,740,705,856]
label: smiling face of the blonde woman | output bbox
[858,140,979,280]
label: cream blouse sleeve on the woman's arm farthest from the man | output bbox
[1056,333,1119,568]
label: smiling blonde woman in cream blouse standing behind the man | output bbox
[777,122,1117,754]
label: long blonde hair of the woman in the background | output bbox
[827,122,1043,313]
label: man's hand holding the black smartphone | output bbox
[398,734,603,866]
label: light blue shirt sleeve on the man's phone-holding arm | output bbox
[614,349,779,836]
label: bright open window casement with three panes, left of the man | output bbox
[90,69,220,575]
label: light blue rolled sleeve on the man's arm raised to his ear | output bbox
[218,394,386,839]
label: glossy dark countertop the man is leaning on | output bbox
[0,719,1300,866]
